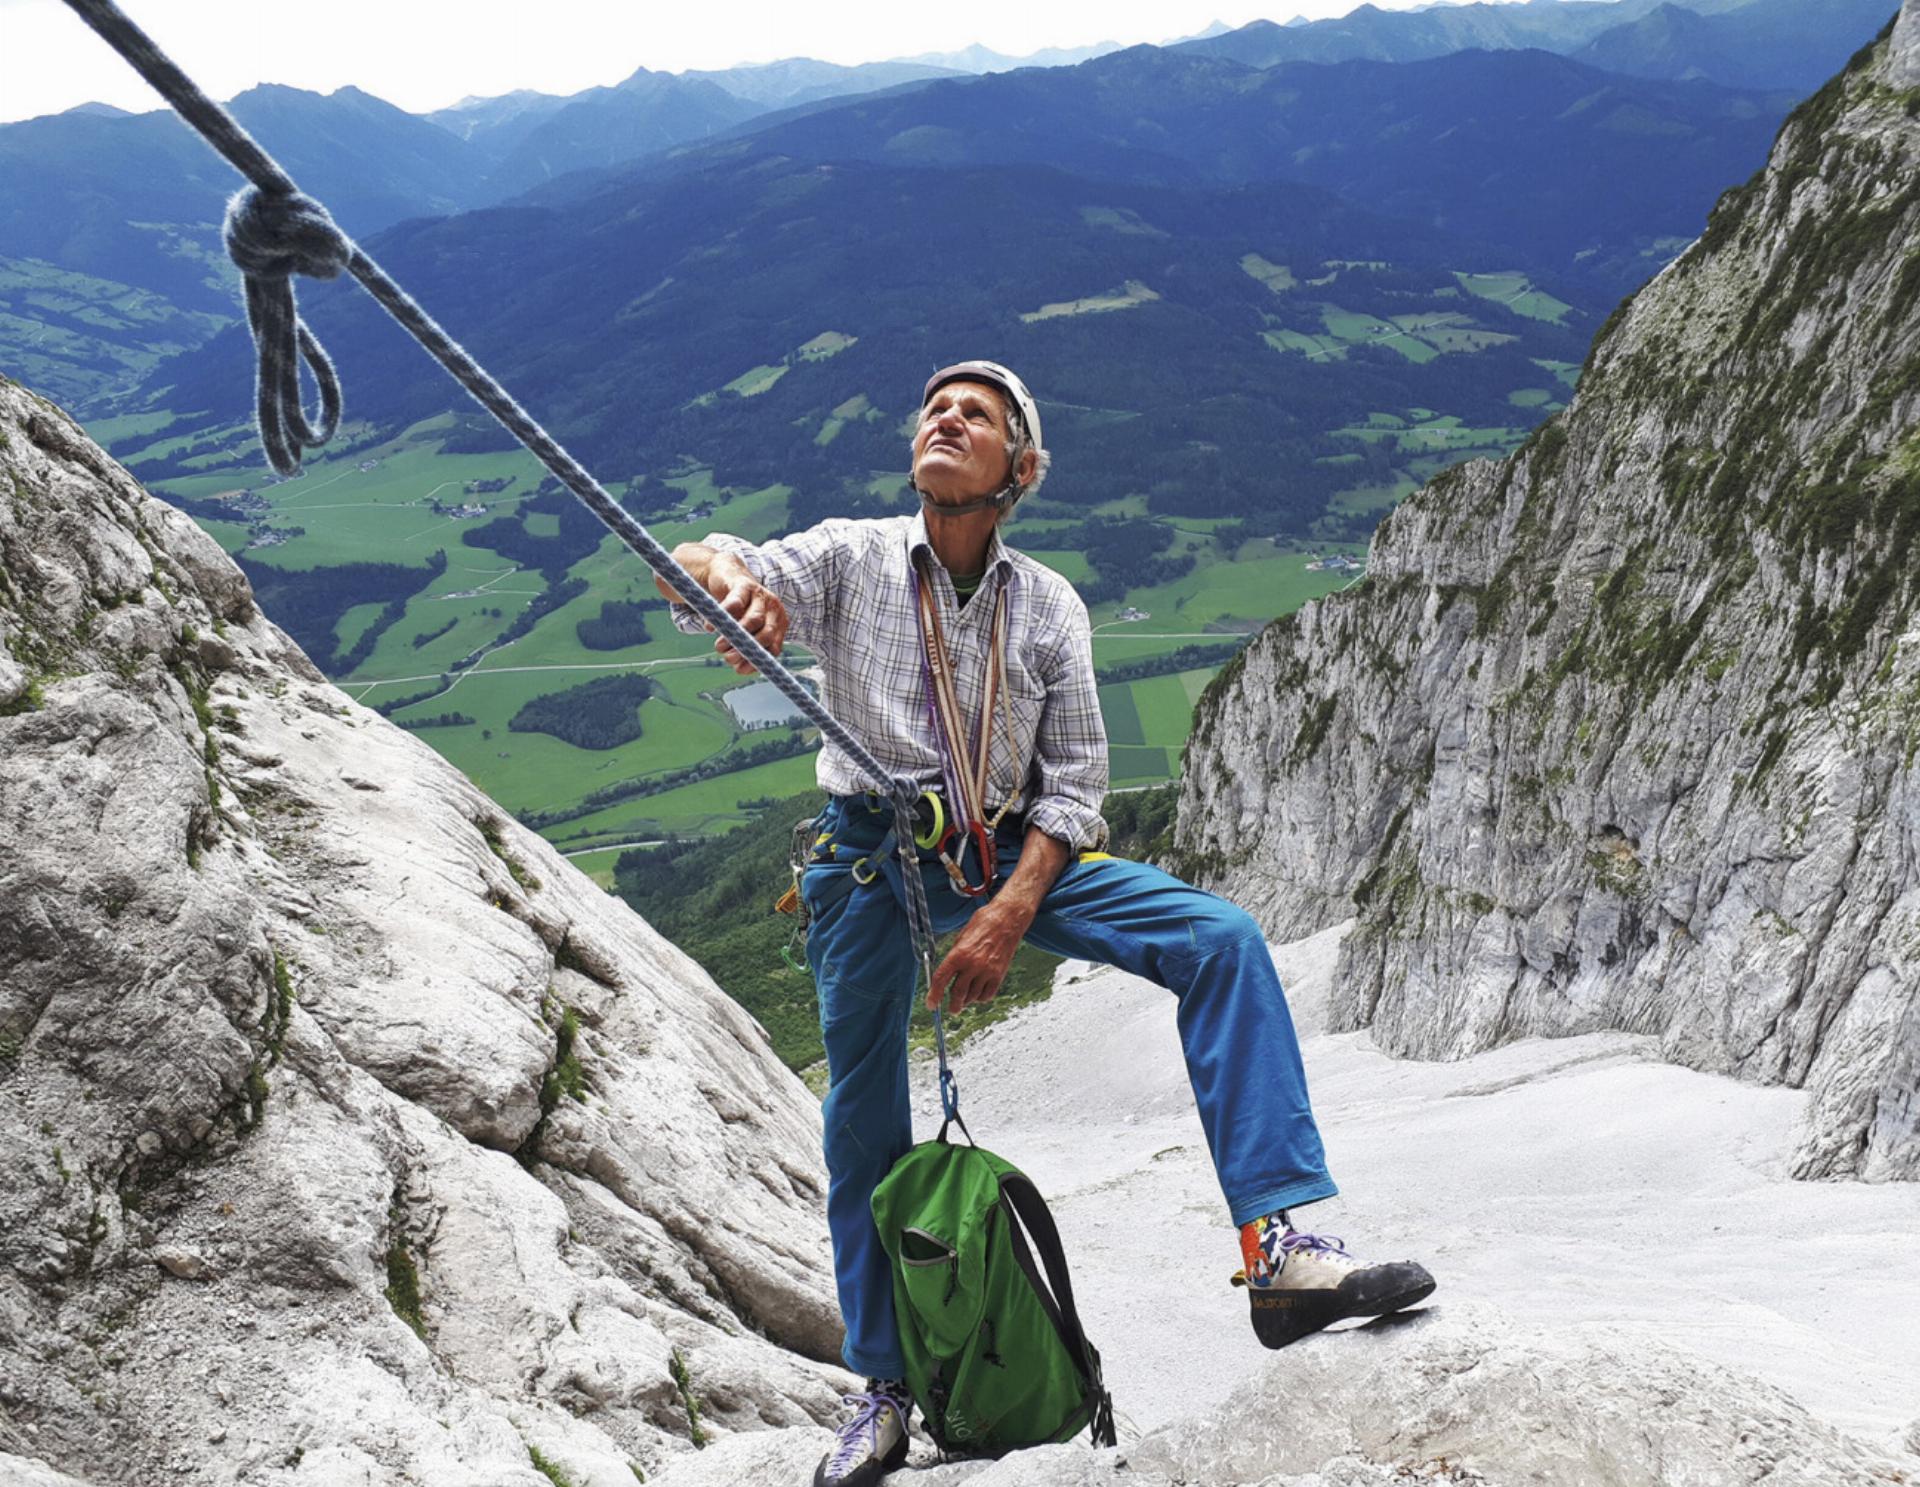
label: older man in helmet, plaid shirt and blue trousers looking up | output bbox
[662,361,1434,1487]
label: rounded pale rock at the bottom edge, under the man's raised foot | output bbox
[637,1308,1916,1487]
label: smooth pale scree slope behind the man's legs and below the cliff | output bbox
[936,928,1920,1439]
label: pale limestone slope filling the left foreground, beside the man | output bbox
[0,380,845,1487]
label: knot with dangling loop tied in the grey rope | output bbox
[221,186,357,475]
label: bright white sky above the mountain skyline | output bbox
[0,0,1466,121]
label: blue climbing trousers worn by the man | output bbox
[801,795,1336,1379]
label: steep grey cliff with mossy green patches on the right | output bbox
[1177,0,1920,1178]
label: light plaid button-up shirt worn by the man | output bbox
[674,515,1108,851]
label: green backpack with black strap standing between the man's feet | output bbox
[874,1124,1116,1456]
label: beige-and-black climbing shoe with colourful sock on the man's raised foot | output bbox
[1233,1210,1434,1347]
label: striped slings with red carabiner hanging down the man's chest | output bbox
[908,549,1025,899]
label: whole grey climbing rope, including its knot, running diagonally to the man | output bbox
[67,0,960,1116]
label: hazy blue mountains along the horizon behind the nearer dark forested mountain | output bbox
[0,0,1885,405]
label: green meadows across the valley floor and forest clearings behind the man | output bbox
[105,256,1578,849]
